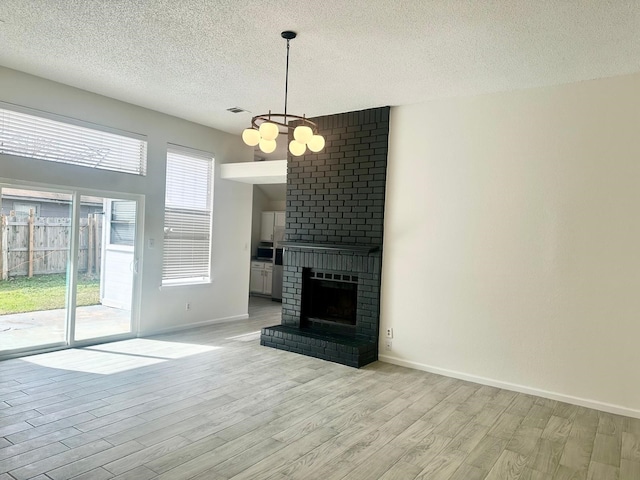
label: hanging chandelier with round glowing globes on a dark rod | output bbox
[242,30,325,157]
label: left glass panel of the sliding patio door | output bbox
[0,187,72,354]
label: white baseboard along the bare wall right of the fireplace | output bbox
[378,355,640,418]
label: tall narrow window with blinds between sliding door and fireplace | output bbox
[162,146,213,285]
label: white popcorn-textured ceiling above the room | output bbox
[0,0,640,139]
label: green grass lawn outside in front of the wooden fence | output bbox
[0,274,100,315]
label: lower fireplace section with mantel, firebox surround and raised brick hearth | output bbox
[260,242,381,367]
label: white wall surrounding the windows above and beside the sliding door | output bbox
[0,67,253,334]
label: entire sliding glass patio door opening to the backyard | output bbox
[0,185,139,357]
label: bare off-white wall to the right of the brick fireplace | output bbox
[380,71,640,416]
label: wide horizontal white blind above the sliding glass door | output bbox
[0,108,147,175]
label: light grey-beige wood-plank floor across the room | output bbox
[0,299,640,480]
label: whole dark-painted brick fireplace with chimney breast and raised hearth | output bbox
[260,107,389,367]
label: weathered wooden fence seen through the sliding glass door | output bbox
[0,210,102,280]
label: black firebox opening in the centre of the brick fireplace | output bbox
[302,269,358,327]
